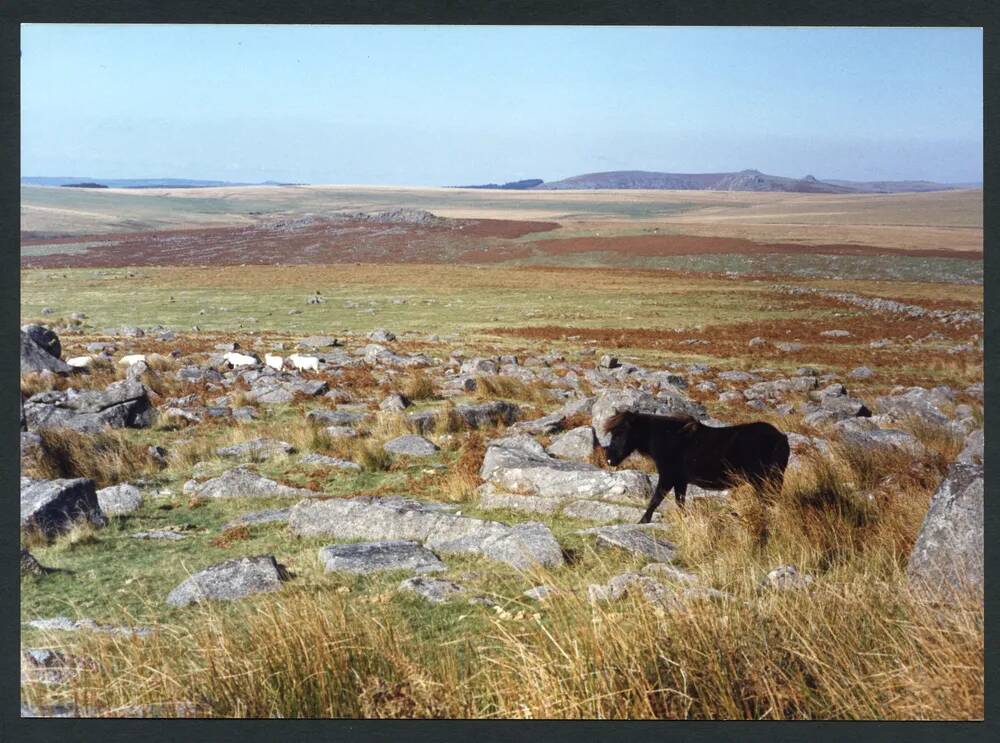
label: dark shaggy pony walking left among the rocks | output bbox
[604,412,789,524]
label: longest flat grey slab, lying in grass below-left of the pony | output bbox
[289,499,564,568]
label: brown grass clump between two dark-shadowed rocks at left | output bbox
[27,428,158,488]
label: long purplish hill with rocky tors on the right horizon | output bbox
[464,170,981,194]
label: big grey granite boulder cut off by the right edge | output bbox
[907,462,984,597]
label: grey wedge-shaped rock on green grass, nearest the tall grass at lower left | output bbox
[167,555,285,607]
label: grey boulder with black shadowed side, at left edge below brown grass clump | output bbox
[21,477,106,537]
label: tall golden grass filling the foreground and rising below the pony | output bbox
[28,442,984,719]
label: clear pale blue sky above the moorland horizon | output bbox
[21,24,983,185]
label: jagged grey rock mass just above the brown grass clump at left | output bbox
[24,379,156,433]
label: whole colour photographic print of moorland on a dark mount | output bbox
[19,23,984,725]
